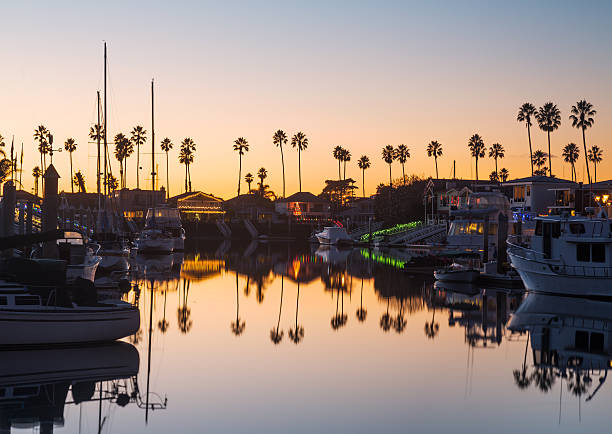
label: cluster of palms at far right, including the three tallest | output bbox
[516,99,603,184]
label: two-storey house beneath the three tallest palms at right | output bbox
[502,176,579,216]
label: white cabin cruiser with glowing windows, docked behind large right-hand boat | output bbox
[446,192,512,258]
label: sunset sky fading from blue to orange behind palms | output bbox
[0,1,612,198]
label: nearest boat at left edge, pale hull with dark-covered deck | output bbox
[0,281,140,346]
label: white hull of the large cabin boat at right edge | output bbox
[508,249,612,297]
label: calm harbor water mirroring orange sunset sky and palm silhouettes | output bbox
[0,241,612,433]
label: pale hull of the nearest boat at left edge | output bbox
[0,306,140,346]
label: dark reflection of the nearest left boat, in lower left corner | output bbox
[0,342,139,433]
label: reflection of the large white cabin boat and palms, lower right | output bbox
[509,293,612,402]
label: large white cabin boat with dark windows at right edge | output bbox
[508,211,612,296]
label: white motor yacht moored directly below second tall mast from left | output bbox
[136,207,185,253]
